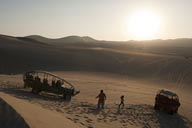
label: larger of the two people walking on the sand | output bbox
[96,90,106,109]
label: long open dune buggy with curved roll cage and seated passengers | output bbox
[23,70,80,100]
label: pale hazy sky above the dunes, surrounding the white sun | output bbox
[0,0,192,40]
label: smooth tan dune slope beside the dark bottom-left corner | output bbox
[0,93,84,128]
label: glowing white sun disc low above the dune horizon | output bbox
[128,11,160,39]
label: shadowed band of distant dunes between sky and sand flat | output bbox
[0,35,192,83]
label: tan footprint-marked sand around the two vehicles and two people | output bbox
[0,72,192,128]
